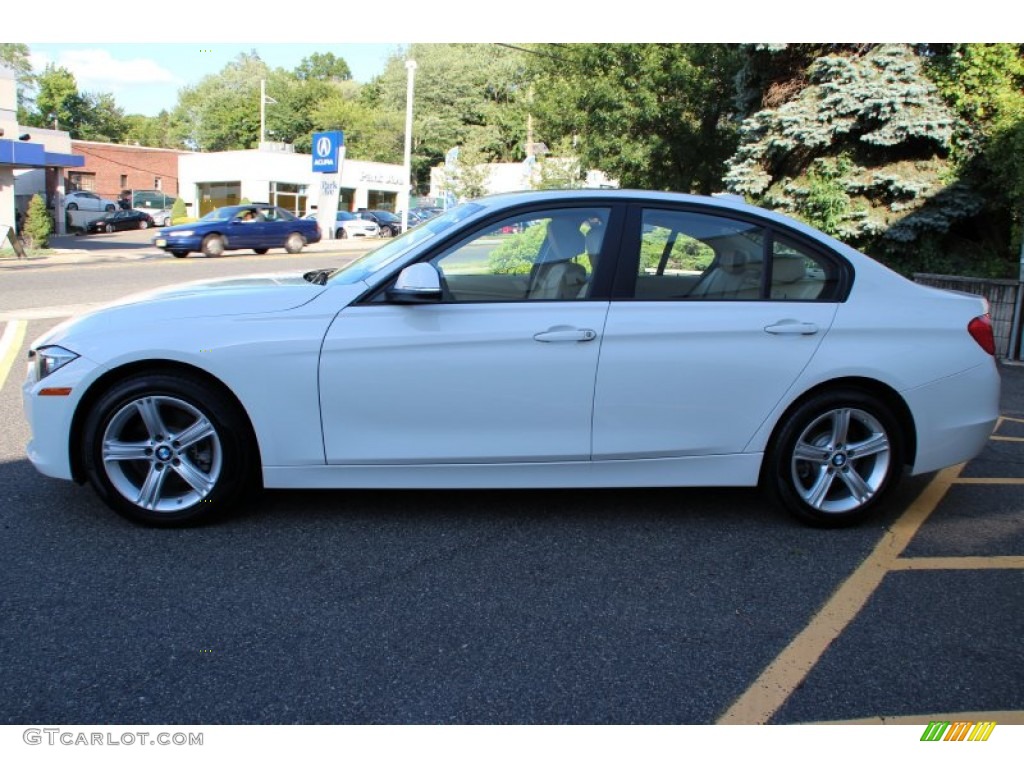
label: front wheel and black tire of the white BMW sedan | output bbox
[80,373,258,526]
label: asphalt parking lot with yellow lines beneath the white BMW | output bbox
[0,241,1024,724]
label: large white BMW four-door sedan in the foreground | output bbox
[24,190,999,525]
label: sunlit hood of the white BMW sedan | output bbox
[37,272,327,345]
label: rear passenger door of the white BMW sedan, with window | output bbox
[594,208,839,460]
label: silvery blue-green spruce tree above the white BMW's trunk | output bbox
[725,45,982,271]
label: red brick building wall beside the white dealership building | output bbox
[65,140,186,200]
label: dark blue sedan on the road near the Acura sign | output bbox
[153,205,321,259]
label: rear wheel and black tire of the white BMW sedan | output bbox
[761,389,903,527]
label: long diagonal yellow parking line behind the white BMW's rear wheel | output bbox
[718,464,964,725]
